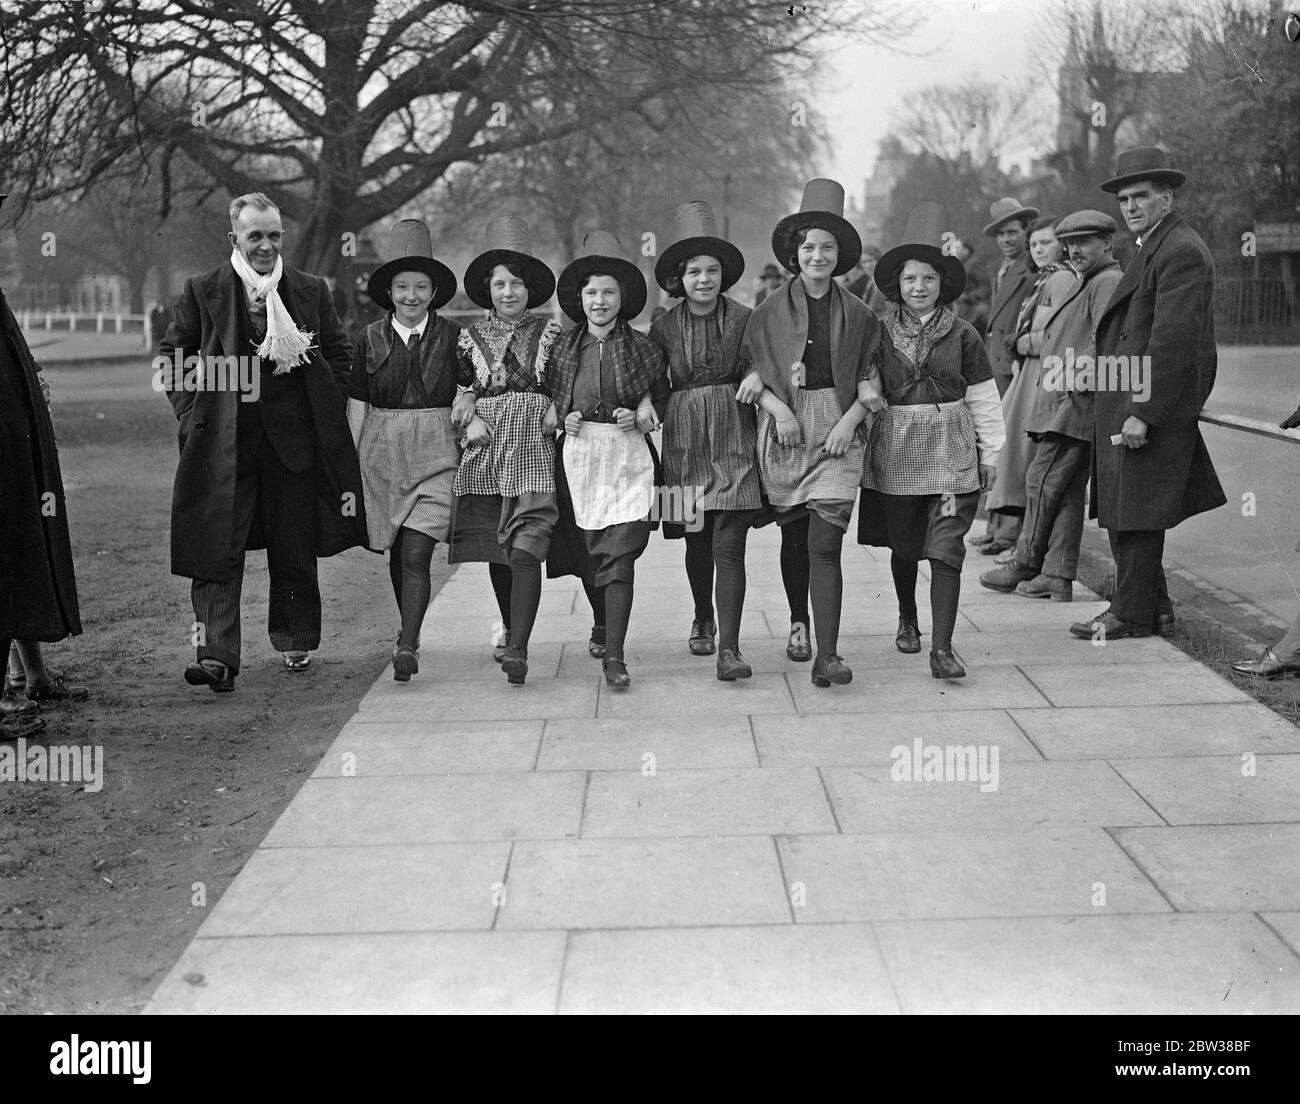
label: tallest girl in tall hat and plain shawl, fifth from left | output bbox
[738,179,884,687]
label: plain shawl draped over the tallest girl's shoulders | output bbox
[741,278,880,411]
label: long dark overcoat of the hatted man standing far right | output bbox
[1091,212,1227,531]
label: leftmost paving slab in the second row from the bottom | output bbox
[204,843,510,936]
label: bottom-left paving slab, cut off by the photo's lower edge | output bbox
[144,931,564,1016]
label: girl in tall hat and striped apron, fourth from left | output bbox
[650,199,762,681]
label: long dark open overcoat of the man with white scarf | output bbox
[160,261,365,583]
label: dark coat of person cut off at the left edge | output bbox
[0,289,82,642]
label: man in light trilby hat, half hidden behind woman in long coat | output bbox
[971,198,1039,555]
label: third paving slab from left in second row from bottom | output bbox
[779,828,1170,925]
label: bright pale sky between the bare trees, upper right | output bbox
[816,0,1056,202]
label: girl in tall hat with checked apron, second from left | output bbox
[447,215,560,685]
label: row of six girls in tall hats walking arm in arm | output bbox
[348,179,1001,689]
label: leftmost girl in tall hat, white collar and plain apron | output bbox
[347,218,469,683]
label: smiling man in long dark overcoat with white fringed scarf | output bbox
[156,192,365,692]
